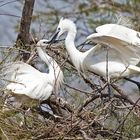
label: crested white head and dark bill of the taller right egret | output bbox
[50,18,76,42]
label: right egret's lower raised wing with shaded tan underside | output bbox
[87,33,140,65]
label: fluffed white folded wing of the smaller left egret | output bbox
[3,62,53,100]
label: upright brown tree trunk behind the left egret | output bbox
[16,0,35,61]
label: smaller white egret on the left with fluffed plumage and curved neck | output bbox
[4,40,63,108]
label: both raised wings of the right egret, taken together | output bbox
[87,24,140,65]
